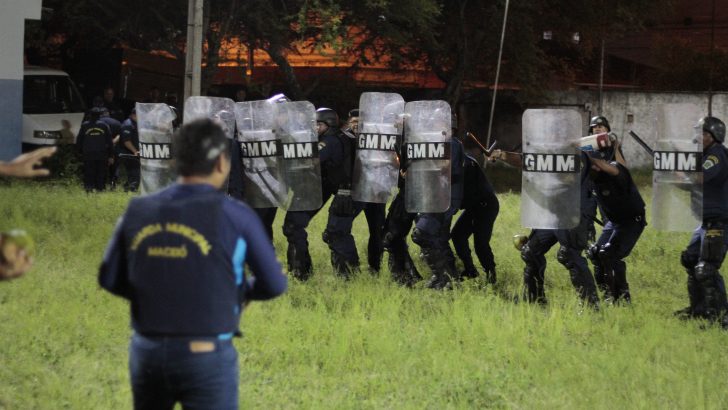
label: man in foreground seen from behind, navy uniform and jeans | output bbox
[99,119,287,409]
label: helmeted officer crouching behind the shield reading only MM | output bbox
[283,107,359,280]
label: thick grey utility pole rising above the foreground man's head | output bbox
[185,0,205,100]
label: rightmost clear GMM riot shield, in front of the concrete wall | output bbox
[651,104,703,232]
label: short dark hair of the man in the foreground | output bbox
[172,118,230,177]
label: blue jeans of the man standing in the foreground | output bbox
[129,334,239,410]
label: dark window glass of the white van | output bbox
[23,75,85,114]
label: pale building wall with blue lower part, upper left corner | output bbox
[0,0,42,160]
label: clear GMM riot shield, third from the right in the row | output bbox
[404,101,452,213]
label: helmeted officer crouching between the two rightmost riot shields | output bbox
[588,116,647,302]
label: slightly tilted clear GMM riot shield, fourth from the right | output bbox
[351,92,404,204]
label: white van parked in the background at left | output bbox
[23,66,86,150]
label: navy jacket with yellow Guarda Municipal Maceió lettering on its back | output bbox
[99,184,287,338]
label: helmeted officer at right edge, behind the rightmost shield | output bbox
[676,117,728,327]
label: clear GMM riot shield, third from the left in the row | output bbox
[235,100,286,208]
